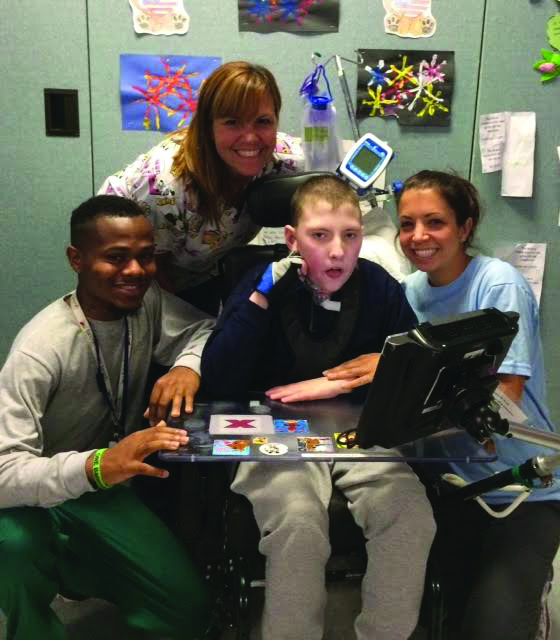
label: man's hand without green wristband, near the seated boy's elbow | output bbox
[144,367,200,426]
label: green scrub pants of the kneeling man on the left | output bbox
[0,486,209,640]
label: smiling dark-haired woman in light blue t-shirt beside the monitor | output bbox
[398,170,560,640]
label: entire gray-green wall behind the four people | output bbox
[0,0,560,424]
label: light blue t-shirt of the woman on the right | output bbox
[403,256,560,502]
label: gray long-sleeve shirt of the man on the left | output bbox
[0,284,214,508]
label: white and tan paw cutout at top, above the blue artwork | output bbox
[128,0,190,36]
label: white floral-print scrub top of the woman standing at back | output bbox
[98,132,303,291]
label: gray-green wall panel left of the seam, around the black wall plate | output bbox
[0,0,92,350]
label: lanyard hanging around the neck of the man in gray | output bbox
[70,292,132,441]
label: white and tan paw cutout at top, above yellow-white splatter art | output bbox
[383,0,437,38]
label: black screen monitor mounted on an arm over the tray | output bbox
[356,309,519,448]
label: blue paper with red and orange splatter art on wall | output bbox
[121,54,221,131]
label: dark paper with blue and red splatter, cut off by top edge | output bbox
[237,0,339,33]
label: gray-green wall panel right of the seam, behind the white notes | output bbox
[471,0,560,416]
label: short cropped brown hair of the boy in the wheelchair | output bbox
[292,174,362,227]
